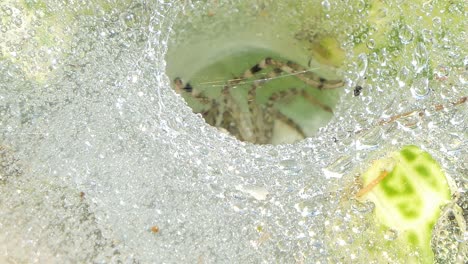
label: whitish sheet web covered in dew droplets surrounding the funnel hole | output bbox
[0,0,468,263]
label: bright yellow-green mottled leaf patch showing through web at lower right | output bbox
[357,145,451,263]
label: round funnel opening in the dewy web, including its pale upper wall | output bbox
[166,1,348,145]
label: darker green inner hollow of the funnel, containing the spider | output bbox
[169,48,343,145]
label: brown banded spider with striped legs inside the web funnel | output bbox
[174,57,344,144]
